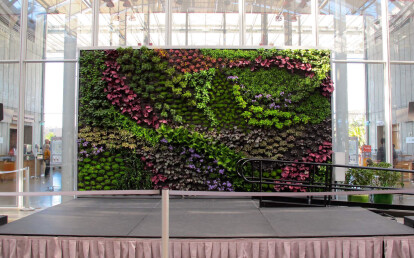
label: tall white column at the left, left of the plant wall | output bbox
[16,0,28,208]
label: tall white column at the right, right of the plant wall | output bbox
[381,0,392,163]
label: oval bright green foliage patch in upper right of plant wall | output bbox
[227,68,330,129]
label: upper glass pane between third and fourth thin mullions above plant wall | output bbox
[245,0,315,46]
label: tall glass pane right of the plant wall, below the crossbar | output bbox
[332,63,386,169]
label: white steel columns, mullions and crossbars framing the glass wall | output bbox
[0,0,414,207]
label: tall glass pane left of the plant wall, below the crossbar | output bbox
[24,63,64,208]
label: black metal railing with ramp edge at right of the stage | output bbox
[236,159,414,209]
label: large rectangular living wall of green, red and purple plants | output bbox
[78,47,333,191]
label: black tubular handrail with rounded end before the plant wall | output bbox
[236,158,414,209]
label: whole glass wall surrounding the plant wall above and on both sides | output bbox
[0,0,414,208]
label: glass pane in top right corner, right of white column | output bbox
[388,1,414,61]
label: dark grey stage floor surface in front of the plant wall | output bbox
[0,198,414,238]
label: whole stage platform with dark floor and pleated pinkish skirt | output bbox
[0,197,414,258]
